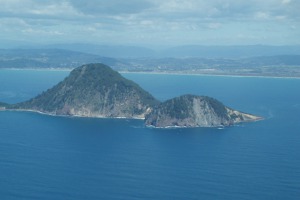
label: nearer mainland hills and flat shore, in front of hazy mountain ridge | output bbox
[0,46,300,77]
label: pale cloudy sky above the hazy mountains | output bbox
[0,0,300,48]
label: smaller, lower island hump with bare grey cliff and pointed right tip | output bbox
[145,95,261,128]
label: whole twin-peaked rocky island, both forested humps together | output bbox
[0,64,262,128]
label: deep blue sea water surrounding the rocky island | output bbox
[0,70,300,200]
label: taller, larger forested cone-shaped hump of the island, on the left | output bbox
[12,64,158,118]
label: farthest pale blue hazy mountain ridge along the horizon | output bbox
[6,43,300,59]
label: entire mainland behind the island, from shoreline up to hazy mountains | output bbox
[0,44,300,77]
